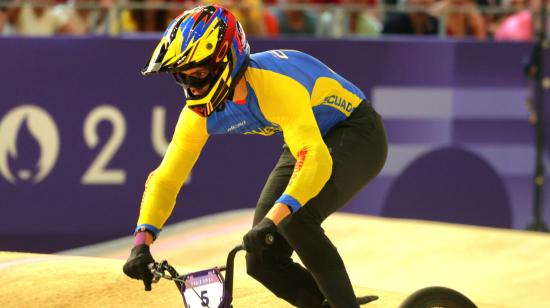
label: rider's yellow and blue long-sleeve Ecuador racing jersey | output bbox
[136,50,365,235]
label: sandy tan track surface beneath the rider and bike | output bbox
[0,211,550,308]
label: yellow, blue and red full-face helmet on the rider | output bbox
[142,5,250,117]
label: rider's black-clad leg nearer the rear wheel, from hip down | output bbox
[278,103,387,308]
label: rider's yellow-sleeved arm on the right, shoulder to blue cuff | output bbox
[256,72,332,218]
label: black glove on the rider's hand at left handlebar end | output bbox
[122,244,155,291]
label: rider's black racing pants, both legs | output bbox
[246,101,387,308]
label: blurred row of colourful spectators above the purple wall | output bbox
[0,0,541,40]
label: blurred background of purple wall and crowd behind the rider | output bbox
[0,0,550,252]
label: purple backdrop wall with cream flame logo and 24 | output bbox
[0,38,550,251]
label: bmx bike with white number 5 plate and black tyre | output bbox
[149,244,477,308]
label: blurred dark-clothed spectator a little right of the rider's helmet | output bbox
[274,0,317,35]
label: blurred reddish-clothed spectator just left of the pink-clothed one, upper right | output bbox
[430,0,487,39]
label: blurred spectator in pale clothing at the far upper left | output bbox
[6,0,64,36]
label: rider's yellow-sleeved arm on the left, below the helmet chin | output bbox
[136,107,208,236]
